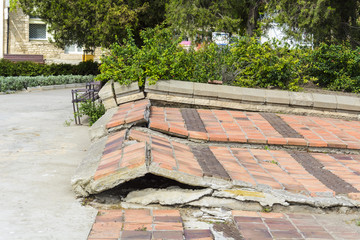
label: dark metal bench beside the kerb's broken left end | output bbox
[71,82,102,124]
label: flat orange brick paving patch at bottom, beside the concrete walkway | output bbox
[88,209,213,240]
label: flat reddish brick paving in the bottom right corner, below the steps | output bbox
[232,211,360,239]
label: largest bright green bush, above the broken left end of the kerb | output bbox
[96,27,231,86]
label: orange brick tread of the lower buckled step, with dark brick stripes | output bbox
[94,129,360,197]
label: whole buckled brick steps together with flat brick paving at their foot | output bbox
[72,82,360,239]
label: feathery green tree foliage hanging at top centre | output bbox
[166,0,265,39]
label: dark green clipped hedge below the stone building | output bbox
[0,59,99,77]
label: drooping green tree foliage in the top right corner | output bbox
[268,0,360,45]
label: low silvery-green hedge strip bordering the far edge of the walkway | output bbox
[0,75,95,92]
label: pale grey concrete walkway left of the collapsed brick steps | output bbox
[0,89,96,240]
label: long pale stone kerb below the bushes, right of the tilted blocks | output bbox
[145,80,360,114]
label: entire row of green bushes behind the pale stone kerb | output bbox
[96,27,360,92]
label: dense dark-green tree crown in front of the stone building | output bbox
[13,0,165,49]
